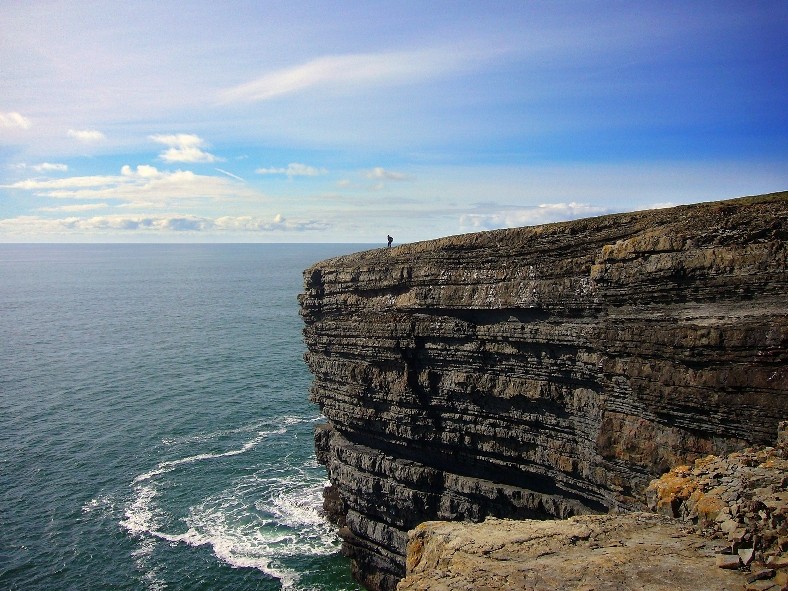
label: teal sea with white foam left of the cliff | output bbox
[0,245,363,591]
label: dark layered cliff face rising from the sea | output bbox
[300,193,788,589]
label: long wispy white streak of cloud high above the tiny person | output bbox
[219,47,484,103]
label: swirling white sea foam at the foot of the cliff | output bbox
[120,417,338,589]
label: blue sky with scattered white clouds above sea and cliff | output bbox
[0,0,788,244]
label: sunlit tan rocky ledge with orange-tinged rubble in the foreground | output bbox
[397,423,788,591]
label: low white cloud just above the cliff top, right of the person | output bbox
[460,202,611,231]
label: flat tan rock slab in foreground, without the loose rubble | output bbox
[397,513,744,591]
